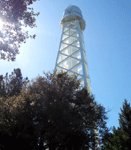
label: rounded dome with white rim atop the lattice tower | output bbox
[60,5,85,30]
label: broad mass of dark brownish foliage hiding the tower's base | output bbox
[0,72,107,150]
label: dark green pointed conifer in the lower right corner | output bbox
[103,100,131,150]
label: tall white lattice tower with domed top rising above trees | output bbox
[55,5,99,150]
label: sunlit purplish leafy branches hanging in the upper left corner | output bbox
[0,0,39,61]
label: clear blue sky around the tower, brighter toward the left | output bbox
[0,0,131,131]
